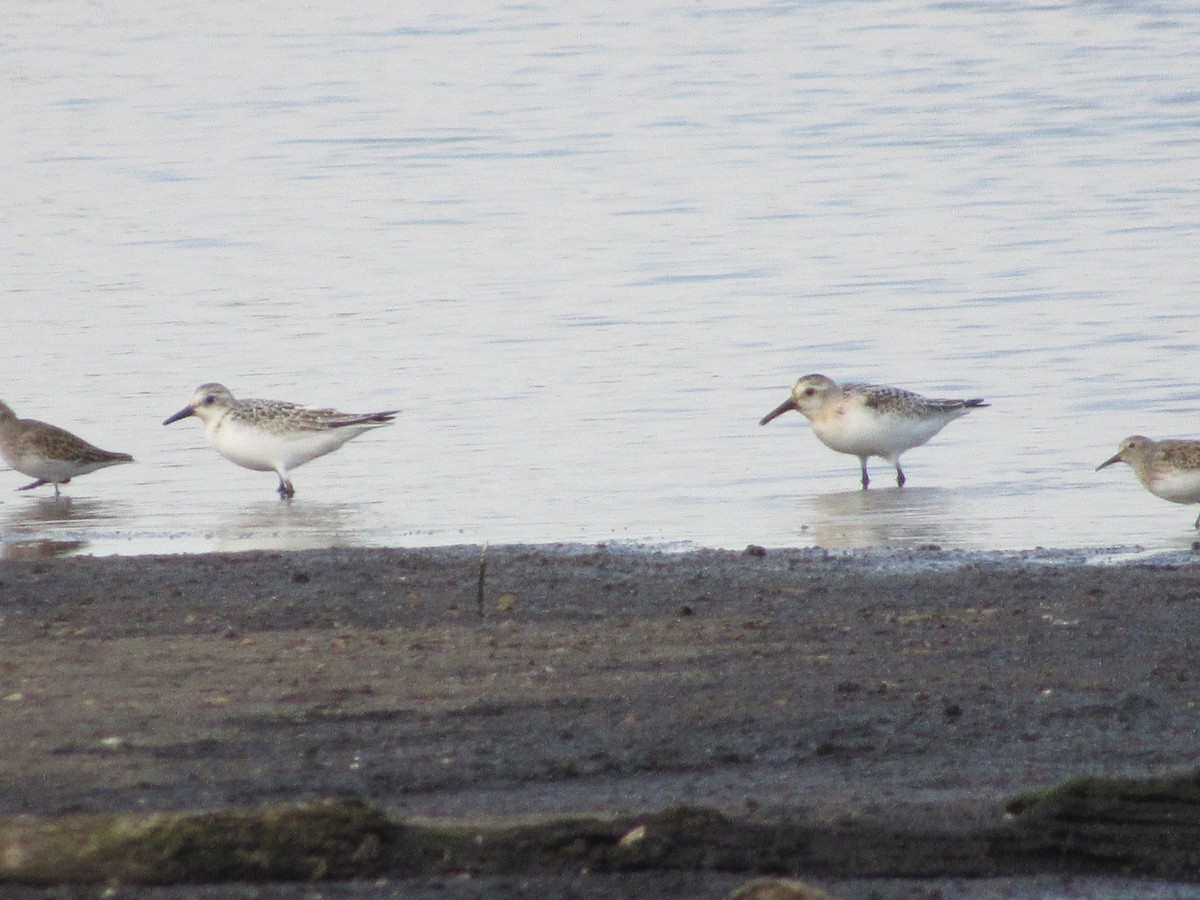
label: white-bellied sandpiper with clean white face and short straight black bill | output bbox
[163,384,400,498]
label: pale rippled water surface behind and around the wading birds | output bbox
[0,0,1200,556]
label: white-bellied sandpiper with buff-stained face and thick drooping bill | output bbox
[758,374,988,488]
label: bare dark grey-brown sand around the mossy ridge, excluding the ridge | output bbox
[0,547,1200,900]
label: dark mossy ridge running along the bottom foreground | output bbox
[7,772,1200,900]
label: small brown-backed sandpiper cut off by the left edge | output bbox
[0,403,133,497]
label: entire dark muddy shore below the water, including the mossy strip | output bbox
[0,547,1200,900]
